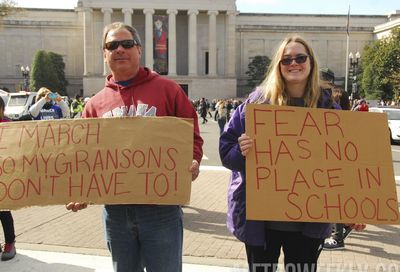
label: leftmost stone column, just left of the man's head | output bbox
[83,8,95,76]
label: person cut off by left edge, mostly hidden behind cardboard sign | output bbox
[0,98,17,261]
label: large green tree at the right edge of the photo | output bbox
[361,27,400,99]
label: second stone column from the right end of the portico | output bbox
[208,10,218,76]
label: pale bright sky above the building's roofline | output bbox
[15,0,400,15]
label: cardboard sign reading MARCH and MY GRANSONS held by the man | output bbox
[0,117,193,209]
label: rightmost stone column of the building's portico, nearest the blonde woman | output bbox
[225,10,237,77]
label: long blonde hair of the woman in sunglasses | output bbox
[256,34,321,108]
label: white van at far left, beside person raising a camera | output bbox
[4,92,36,120]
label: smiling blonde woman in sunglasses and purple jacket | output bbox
[219,35,339,272]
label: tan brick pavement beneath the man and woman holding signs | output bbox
[0,167,400,272]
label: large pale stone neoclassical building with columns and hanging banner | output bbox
[0,0,400,99]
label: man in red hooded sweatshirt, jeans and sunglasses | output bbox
[67,23,203,272]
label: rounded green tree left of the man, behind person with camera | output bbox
[29,50,68,95]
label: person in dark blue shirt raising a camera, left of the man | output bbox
[29,87,70,120]
